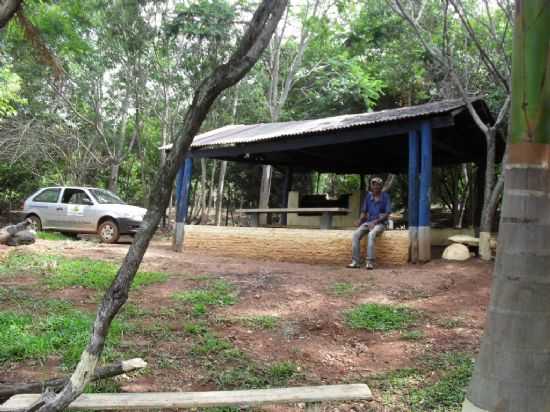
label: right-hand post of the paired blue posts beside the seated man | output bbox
[418,120,432,262]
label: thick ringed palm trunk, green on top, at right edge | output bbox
[462,0,550,412]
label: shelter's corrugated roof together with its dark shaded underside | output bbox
[166,99,504,173]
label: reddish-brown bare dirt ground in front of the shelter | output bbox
[0,240,492,411]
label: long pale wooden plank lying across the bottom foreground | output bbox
[0,384,372,412]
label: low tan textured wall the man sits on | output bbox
[184,225,409,265]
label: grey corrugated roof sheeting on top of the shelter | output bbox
[161,99,478,149]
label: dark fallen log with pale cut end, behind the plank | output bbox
[0,358,147,402]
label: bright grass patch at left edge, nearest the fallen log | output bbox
[0,309,124,368]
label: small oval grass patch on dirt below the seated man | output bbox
[344,303,419,331]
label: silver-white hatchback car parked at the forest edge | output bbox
[23,187,147,243]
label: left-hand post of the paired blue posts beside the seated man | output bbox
[409,130,420,263]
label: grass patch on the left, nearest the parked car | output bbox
[0,253,168,290]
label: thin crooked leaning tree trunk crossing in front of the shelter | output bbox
[33,0,287,412]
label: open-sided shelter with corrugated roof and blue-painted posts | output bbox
[165,99,503,261]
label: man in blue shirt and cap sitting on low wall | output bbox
[348,177,391,269]
